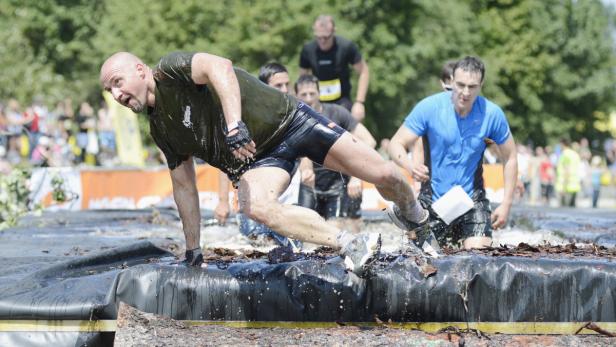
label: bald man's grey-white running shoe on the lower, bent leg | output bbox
[340,234,381,277]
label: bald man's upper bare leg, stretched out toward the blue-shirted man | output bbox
[324,133,425,221]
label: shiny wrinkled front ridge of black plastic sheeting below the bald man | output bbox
[116,256,616,322]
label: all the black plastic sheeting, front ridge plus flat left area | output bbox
[0,208,616,346]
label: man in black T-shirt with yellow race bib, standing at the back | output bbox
[299,15,370,122]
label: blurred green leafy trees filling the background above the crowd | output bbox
[0,0,616,144]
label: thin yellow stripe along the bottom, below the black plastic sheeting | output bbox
[0,320,616,335]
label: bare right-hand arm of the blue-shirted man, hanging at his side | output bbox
[492,135,518,229]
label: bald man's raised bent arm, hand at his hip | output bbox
[191,53,256,160]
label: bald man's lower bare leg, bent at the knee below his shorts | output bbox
[238,167,340,249]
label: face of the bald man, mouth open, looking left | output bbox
[101,64,147,113]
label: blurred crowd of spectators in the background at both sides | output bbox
[0,98,616,207]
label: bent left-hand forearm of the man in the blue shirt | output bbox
[388,125,429,182]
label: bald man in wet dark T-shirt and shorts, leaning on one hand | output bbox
[100,52,428,275]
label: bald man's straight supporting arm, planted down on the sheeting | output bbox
[170,157,201,250]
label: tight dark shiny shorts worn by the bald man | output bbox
[248,102,345,176]
